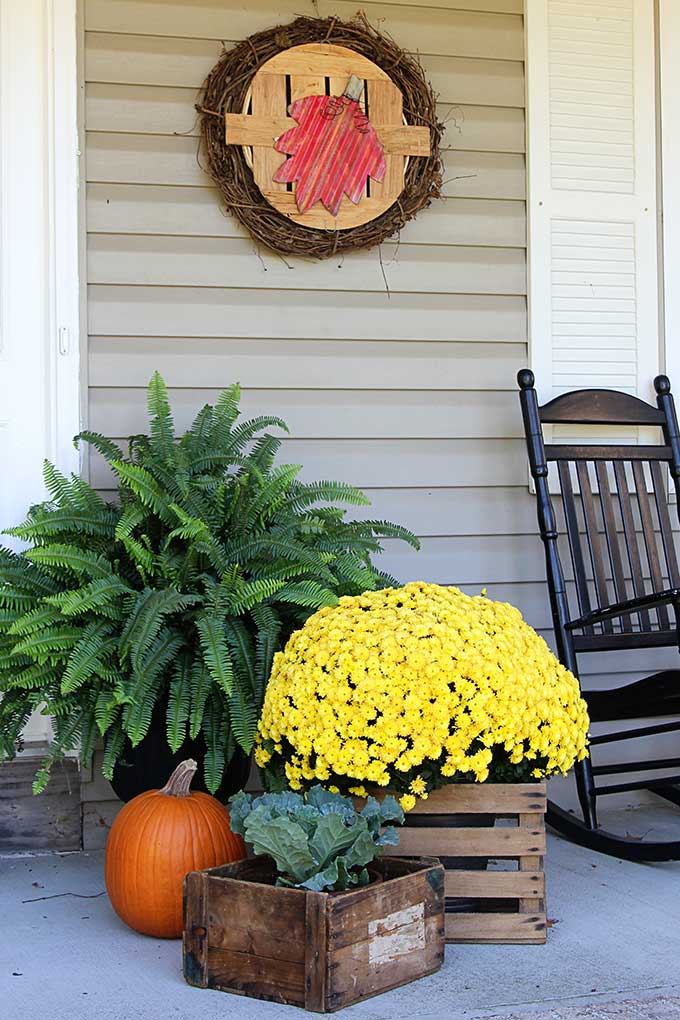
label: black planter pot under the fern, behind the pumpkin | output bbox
[111,701,251,804]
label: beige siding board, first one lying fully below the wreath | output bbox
[89,285,526,343]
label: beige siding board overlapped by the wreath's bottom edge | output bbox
[88,235,526,295]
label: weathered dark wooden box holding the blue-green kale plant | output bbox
[184,857,444,1013]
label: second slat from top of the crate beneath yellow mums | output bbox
[399,826,545,857]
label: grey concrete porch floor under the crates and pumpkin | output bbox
[0,809,680,1020]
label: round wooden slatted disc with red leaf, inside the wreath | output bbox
[224,43,430,231]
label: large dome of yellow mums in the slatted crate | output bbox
[255,582,588,809]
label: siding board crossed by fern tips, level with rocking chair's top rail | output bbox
[89,388,522,436]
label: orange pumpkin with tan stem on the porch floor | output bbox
[105,759,246,938]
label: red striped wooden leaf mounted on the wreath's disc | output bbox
[274,96,385,216]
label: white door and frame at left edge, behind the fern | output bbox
[0,0,81,741]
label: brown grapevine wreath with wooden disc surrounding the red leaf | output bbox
[197,13,442,259]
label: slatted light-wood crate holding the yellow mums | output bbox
[383,782,546,944]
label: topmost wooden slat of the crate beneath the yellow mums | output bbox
[399,782,546,815]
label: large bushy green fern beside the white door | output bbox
[0,374,417,789]
